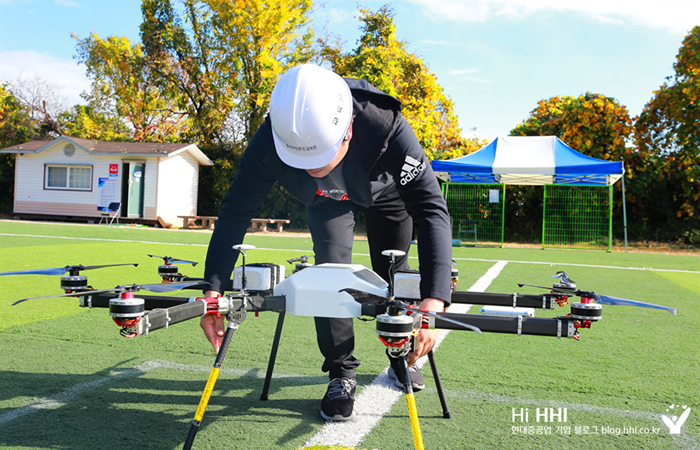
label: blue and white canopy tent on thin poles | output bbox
[432,136,627,248]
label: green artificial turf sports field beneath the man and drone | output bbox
[0,221,700,450]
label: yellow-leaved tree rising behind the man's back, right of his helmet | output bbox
[321,5,476,159]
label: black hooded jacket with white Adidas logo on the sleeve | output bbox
[204,79,452,302]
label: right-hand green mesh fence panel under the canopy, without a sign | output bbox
[542,184,612,251]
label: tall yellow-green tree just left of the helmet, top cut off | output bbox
[141,0,312,148]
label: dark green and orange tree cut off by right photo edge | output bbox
[632,26,700,244]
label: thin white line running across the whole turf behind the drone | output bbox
[0,233,700,274]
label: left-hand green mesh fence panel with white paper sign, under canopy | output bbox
[442,183,505,247]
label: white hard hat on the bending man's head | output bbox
[270,64,352,169]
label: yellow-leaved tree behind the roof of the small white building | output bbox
[74,33,189,142]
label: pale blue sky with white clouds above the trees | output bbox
[0,0,700,140]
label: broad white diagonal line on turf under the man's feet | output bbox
[304,261,507,447]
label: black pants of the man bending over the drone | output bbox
[306,192,413,379]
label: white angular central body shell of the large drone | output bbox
[274,264,389,318]
